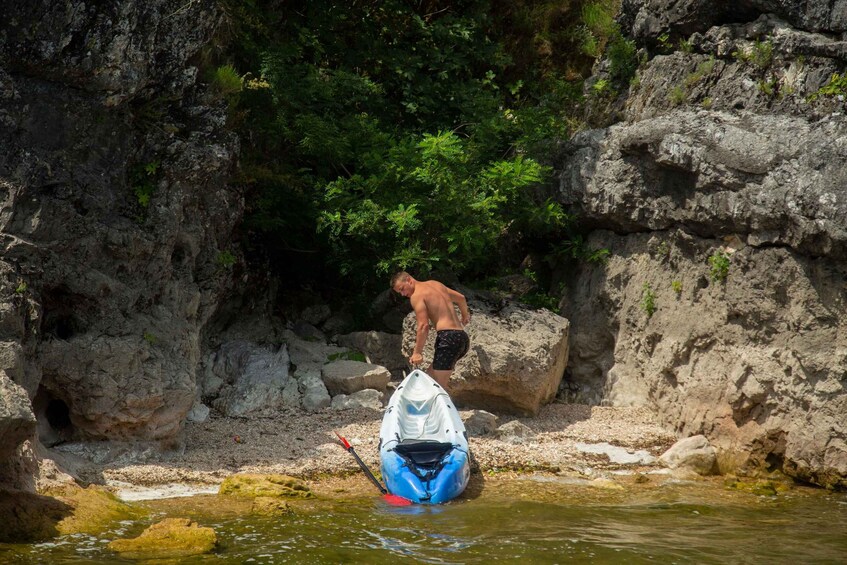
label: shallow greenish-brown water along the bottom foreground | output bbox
[0,478,847,565]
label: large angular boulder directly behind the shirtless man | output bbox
[403,292,568,414]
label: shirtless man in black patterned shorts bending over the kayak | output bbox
[391,271,471,392]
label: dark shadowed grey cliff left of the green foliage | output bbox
[0,0,242,480]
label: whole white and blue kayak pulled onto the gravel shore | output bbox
[379,370,470,504]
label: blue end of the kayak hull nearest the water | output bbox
[381,449,470,504]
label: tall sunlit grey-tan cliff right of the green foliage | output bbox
[559,0,847,487]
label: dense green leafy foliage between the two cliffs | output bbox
[215,0,608,300]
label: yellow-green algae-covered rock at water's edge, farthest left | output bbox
[44,485,145,535]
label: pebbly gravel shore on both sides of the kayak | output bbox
[79,403,676,494]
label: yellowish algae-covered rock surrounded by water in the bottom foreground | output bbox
[109,518,218,559]
